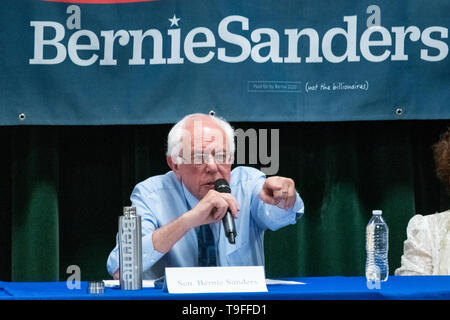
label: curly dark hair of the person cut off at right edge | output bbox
[433,126,450,194]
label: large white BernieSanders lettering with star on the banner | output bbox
[29,6,448,66]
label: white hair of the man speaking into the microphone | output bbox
[166,113,235,163]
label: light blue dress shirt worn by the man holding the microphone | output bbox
[107,167,304,279]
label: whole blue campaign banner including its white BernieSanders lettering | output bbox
[0,0,450,125]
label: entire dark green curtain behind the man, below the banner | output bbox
[0,120,450,281]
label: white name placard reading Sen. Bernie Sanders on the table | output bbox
[165,266,267,293]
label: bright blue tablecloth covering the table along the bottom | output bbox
[0,276,450,300]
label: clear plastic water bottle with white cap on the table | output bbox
[366,210,389,282]
